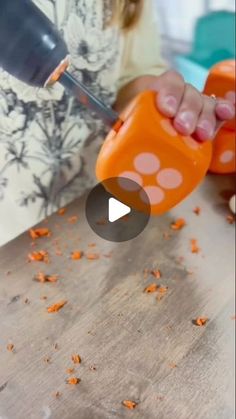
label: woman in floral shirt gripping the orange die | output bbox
[0,0,234,244]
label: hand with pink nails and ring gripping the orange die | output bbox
[152,71,235,141]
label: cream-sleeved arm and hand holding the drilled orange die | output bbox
[115,0,235,141]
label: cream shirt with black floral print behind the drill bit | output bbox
[0,0,163,245]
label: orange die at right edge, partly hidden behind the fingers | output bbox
[204,60,236,174]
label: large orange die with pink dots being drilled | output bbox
[96,91,212,215]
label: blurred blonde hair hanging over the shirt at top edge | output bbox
[113,0,144,29]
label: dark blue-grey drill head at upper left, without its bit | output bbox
[0,0,68,87]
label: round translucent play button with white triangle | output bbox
[86,177,151,242]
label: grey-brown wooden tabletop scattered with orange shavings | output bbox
[0,177,235,419]
